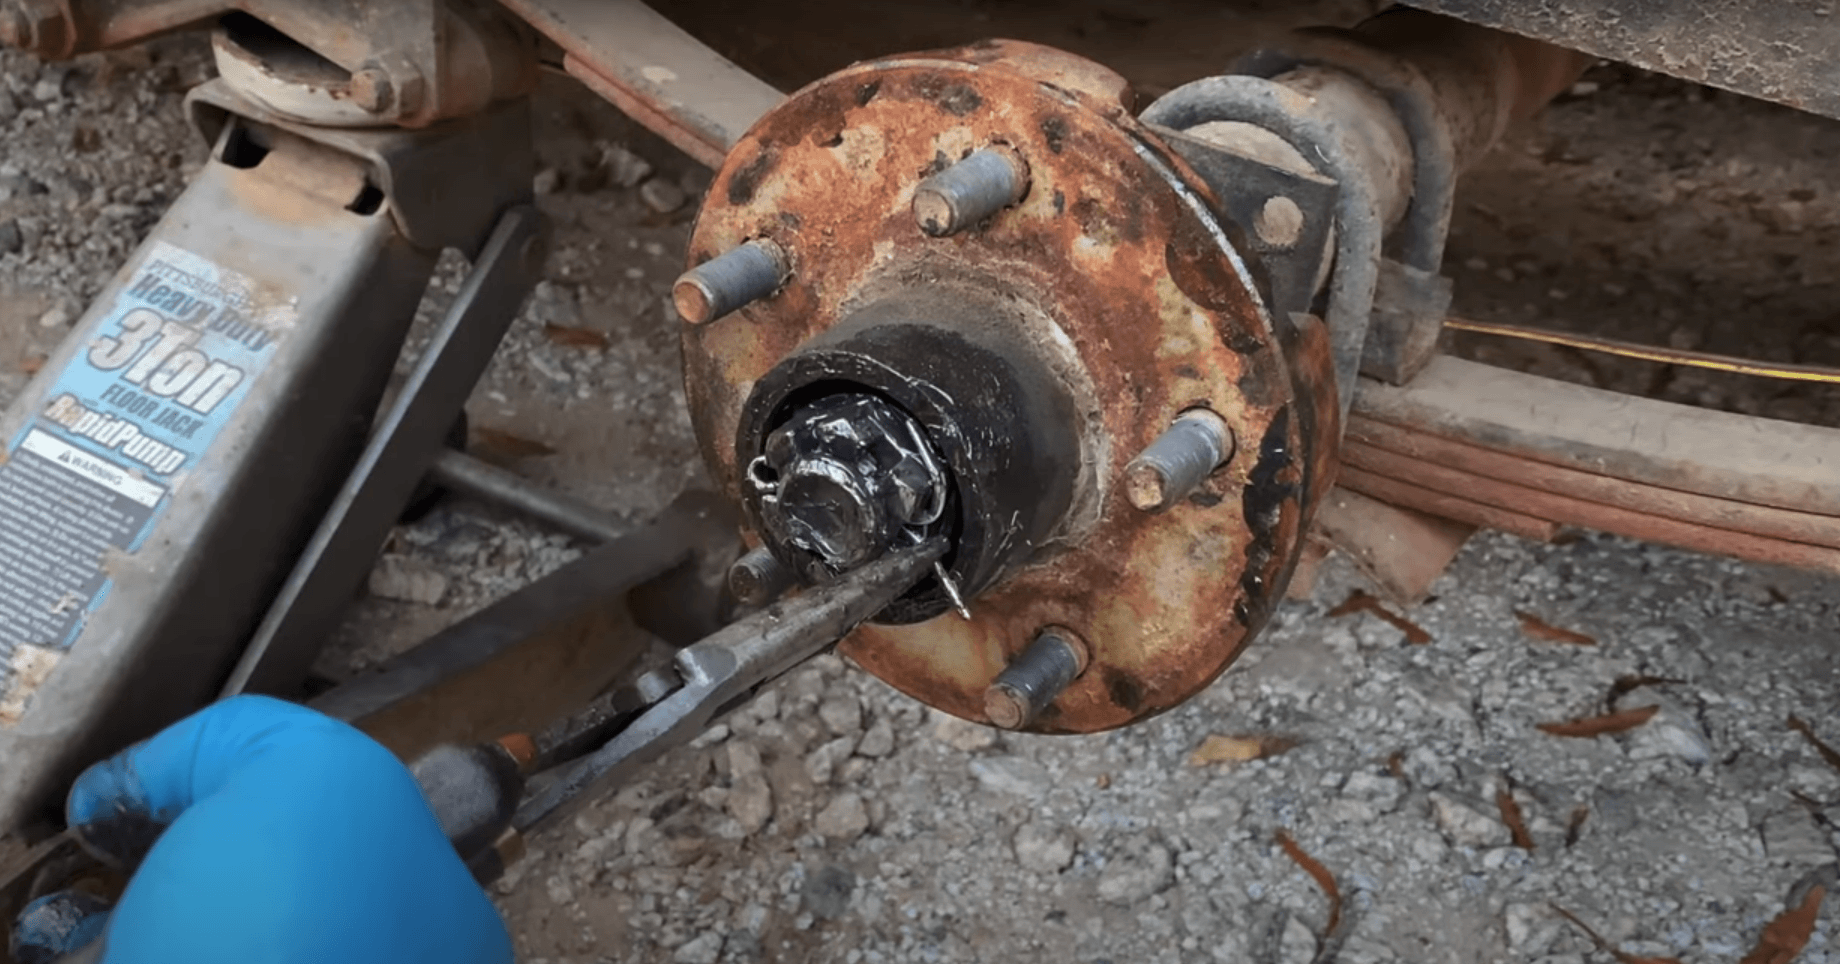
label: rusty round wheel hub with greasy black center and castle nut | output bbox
[679,42,1336,732]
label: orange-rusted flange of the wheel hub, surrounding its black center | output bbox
[684,42,1336,732]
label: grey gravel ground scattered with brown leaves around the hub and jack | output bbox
[0,0,1840,964]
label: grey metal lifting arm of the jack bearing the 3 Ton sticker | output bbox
[0,81,541,832]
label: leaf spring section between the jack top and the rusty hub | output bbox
[504,0,784,167]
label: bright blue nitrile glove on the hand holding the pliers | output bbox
[55,697,512,964]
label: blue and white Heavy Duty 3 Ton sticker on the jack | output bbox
[0,241,294,725]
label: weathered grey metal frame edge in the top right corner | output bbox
[1408,0,1840,118]
